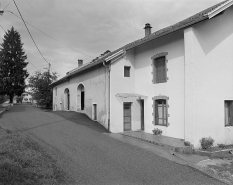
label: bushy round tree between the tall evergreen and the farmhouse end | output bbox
[29,69,58,108]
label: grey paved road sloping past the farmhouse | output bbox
[0,105,226,185]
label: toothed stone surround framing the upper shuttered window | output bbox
[151,52,168,84]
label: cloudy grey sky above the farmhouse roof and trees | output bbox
[0,0,223,78]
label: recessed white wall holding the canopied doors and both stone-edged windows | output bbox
[111,31,184,138]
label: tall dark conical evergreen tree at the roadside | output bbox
[0,27,29,103]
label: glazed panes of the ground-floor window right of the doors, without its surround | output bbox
[154,99,168,126]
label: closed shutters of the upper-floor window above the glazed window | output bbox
[154,56,167,83]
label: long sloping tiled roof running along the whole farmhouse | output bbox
[51,0,230,86]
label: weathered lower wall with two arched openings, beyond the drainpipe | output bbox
[53,66,108,128]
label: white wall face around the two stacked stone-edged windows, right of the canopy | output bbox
[135,31,184,139]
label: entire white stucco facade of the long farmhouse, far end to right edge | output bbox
[53,2,233,148]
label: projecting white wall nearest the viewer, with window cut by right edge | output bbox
[184,7,233,148]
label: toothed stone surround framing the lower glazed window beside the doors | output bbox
[152,96,170,127]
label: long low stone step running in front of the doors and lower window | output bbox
[120,133,193,154]
